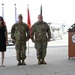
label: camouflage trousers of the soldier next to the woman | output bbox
[15,41,26,61]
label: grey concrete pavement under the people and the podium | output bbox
[0,46,75,75]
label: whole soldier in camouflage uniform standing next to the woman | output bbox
[11,14,30,65]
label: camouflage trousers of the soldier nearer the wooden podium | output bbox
[35,40,47,59]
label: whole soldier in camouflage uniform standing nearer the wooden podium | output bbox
[31,15,51,64]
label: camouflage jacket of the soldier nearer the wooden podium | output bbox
[32,21,51,40]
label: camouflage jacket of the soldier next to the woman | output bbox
[11,22,30,41]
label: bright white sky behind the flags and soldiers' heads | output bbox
[0,0,75,31]
